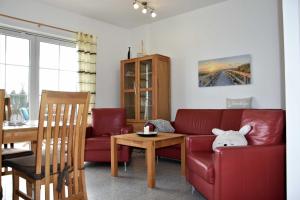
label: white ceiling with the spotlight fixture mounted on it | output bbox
[37,0,225,28]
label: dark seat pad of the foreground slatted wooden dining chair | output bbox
[3,155,67,180]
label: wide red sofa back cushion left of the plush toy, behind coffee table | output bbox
[174,109,222,135]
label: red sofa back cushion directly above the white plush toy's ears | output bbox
[220,109,243,131]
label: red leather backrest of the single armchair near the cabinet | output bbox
[92,108,126,136]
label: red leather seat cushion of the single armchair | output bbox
[85,136,120,151]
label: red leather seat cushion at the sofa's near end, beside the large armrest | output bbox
[187,152,215,184]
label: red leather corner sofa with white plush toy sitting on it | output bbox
[157,109,285,200]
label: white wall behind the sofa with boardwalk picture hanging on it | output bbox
[130,0,284,117]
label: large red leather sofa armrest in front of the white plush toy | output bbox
[215,145,285,199]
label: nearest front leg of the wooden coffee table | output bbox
[146,141,155,188]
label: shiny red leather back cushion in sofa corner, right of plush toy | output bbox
[241,110,285,145]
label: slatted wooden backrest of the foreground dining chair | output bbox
[36,91,90,199]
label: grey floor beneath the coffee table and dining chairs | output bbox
[2,150,205,200]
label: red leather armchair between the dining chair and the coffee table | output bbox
[85,108,133,166]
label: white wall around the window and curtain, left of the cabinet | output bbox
[0,0,129,107]
